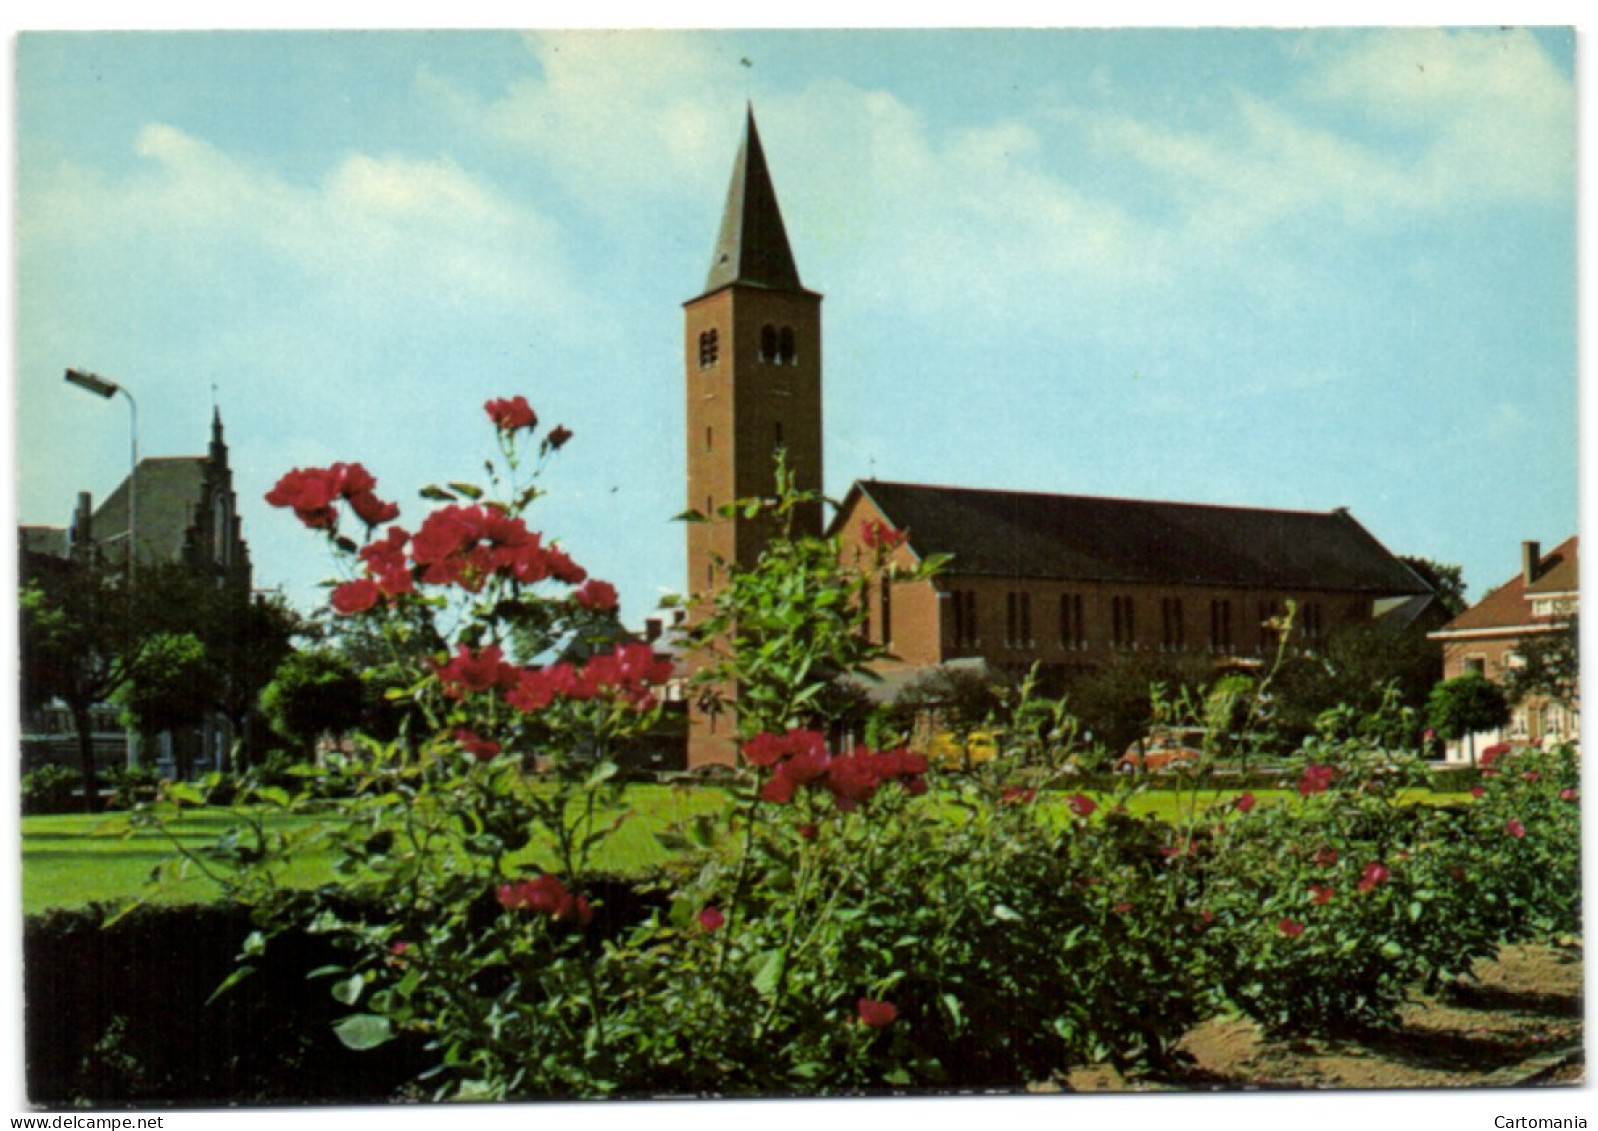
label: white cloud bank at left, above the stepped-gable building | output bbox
[22,125,577,329]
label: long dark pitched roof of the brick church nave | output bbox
[845,481,1430,596]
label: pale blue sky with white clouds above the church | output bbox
[16,29,1577,625]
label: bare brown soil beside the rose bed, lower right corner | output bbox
[1066,946,1585,1091]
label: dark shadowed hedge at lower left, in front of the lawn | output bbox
[22,880,650,1109]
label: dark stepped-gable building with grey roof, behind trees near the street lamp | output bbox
[19,412,251,775]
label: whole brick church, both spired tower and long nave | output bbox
[684,109,1432,767]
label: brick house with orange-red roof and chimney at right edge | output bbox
[1430,535,1580,762]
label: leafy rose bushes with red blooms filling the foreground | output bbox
[136,396,1580,1099]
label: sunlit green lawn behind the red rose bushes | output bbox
[22,786,1467,915]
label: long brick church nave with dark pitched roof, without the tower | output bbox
[833,481,1430,673]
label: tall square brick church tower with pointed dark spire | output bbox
[682,109,821,765]
